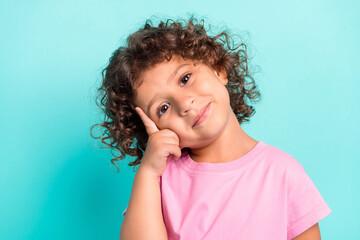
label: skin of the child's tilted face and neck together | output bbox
[134,57,257,163]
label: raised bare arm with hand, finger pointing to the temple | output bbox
[120,107,181,240]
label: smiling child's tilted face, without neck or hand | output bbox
[134,56,233,149]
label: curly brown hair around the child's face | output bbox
[91,17,260,172]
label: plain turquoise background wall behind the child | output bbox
[0,0,360,239]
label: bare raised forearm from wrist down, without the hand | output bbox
[120,164,167,240]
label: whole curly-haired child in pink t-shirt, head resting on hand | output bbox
[92,18,331,240]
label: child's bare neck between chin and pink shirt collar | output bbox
[190,112,258,163]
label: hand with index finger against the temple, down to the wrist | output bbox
[135,107,181,177]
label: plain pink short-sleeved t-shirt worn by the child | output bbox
[122,141,331,240]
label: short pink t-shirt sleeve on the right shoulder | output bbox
[287,160,331,239]
